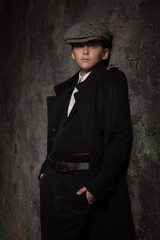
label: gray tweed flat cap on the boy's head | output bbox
[64,22,111,44]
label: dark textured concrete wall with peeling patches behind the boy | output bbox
[0,0,160,240]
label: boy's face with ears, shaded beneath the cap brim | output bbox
[71,41,109,76]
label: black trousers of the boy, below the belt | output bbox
[40,167,90,240]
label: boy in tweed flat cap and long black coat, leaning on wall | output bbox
[40,22,135,240]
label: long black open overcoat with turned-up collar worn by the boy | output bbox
[40,64,134,240]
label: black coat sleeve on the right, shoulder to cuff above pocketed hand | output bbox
[86,71,132,201]
